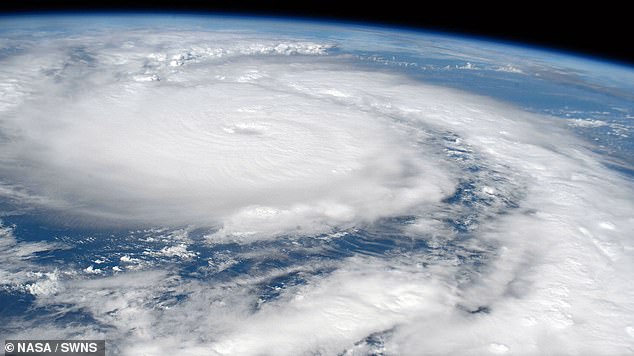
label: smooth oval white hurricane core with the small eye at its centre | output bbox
[1,33,455,238]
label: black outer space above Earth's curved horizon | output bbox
[0,0,634,65]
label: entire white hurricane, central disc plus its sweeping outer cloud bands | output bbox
[0,17,634,355]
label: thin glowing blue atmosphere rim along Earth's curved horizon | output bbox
[0,8,634,71]
